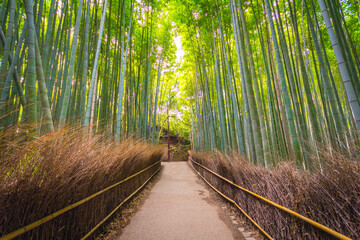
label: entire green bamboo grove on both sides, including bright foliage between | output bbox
[0,0,360,169]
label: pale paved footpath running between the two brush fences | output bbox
[119,162,244,240]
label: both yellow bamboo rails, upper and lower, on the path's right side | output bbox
[190,157,351,240]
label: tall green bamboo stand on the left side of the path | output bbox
[0,0,179,141]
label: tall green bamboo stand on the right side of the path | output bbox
[172,0,360,169]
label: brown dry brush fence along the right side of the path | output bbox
[190,152,360,239]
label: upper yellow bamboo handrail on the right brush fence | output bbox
[189,157,351,240]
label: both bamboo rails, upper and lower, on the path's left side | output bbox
[0,161,160,240]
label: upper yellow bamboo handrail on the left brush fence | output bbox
[0,161,160,240]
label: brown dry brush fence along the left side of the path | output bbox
[0,127,164,239]
